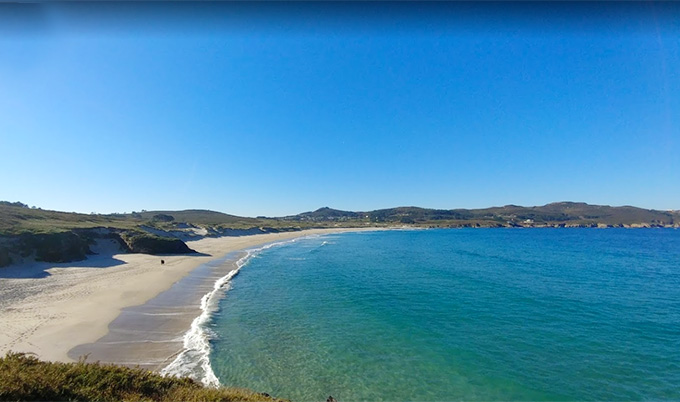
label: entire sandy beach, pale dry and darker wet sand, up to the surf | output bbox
[0,229,374,370]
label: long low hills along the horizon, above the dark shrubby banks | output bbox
[0,201,680,236]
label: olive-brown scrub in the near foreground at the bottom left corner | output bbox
[0,353,277,402]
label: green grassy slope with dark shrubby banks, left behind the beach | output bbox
[0,201,311,267]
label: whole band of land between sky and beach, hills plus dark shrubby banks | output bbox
[0,201,680,267]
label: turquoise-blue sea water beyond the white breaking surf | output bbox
[205,229,680,401]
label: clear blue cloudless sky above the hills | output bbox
[0,2,680,216]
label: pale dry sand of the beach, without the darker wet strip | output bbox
[0,229,361,369]
